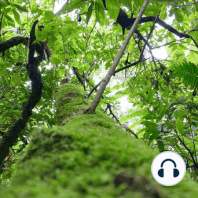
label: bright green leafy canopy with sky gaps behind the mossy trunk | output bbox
[0,0,198,186]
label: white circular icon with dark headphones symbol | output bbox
[151,151,186,186]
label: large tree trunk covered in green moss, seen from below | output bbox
[0,84,198,198]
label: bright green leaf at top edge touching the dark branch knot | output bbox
[106,0,120,21]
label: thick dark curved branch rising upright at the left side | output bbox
[0,21,43,165]
